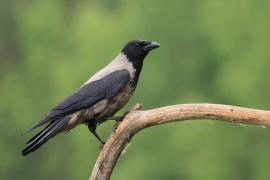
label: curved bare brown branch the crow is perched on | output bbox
[89,104,270,180]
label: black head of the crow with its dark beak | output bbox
[122,40,160,63]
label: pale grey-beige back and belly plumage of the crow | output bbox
[63,53,136,131]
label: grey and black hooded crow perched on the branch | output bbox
[22,40,160,156]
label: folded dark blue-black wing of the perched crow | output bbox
[28,69,130,131]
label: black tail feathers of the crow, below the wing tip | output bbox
[22,117,69,156]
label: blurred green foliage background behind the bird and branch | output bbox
[0,0,270,180]
